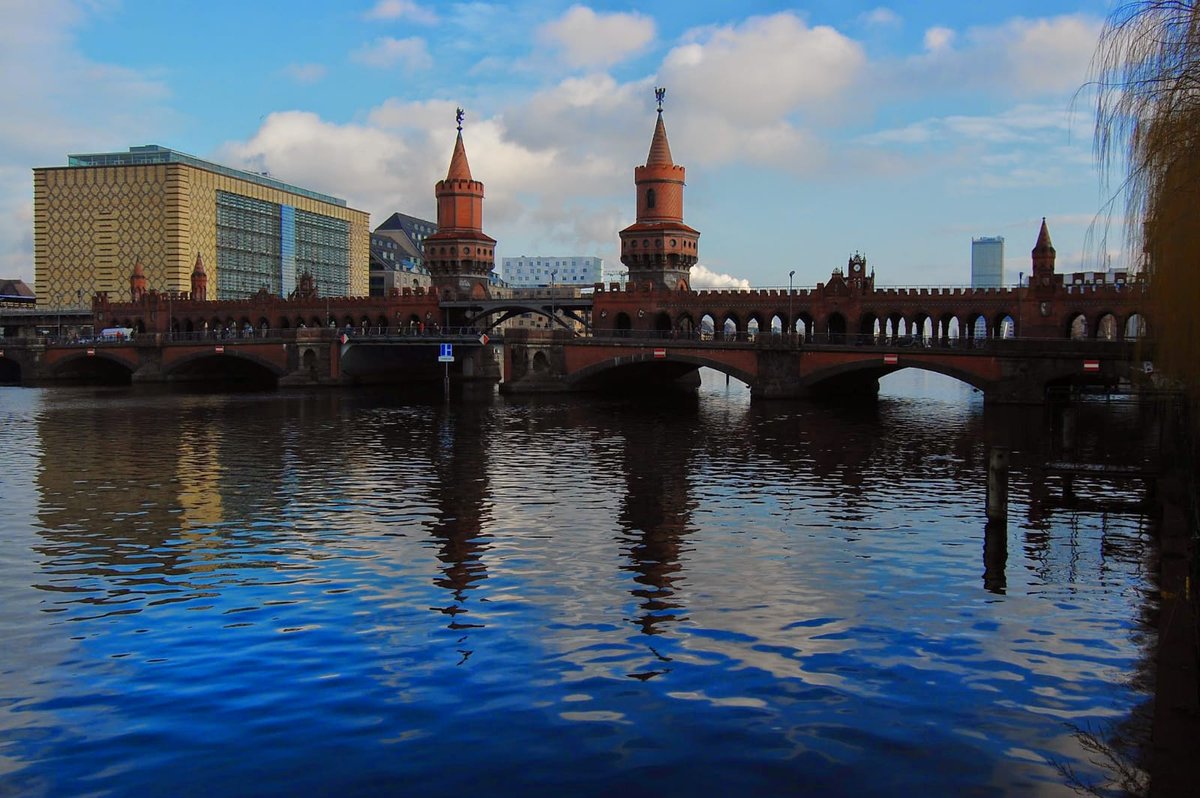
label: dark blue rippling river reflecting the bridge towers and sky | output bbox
[0,372,1157,798]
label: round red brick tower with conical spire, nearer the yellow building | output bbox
[424,108,496,299]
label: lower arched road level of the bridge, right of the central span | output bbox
[500,335,1148,403]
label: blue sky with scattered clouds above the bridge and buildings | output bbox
[0,0,1124,287]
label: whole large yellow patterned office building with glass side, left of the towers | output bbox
[34,145,370,308]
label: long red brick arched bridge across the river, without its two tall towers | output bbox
[0,241,1153,403]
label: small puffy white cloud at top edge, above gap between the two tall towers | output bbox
[538,6,654,67]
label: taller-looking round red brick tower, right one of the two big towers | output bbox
[620,89,700,290]
